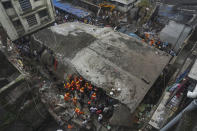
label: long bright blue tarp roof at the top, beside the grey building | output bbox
[53,0,90,18]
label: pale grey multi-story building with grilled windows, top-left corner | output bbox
[0,0,55,40]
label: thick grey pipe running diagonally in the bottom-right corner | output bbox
[160,99,197,131]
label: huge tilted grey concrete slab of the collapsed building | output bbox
[34,23,171,113]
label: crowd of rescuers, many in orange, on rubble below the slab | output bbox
[64,75,116,126]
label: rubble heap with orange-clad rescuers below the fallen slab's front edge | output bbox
[40,75,118,130]
